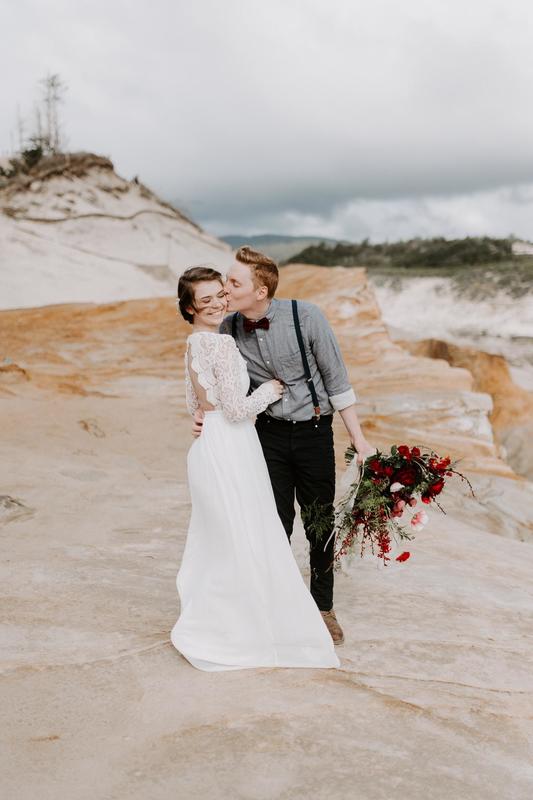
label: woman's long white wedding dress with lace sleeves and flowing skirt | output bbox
[171,332,339,671]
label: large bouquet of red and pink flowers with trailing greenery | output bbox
[328,444,474,566]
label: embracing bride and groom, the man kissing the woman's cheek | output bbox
[171,247,374,671]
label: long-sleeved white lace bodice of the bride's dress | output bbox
[185,331,278,422]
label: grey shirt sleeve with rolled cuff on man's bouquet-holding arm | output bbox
[307,303,357,411]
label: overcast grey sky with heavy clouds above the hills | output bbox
[0,0,533,241]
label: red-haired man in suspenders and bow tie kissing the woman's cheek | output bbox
[193,247,374,645]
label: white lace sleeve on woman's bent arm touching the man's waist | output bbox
[213,335,278,422]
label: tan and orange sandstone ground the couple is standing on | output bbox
[0,266,533,800]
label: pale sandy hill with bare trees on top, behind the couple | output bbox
[0,153,232,308]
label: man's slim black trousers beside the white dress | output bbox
[256,414,335,611]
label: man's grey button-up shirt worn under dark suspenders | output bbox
[220,299,355,422]
